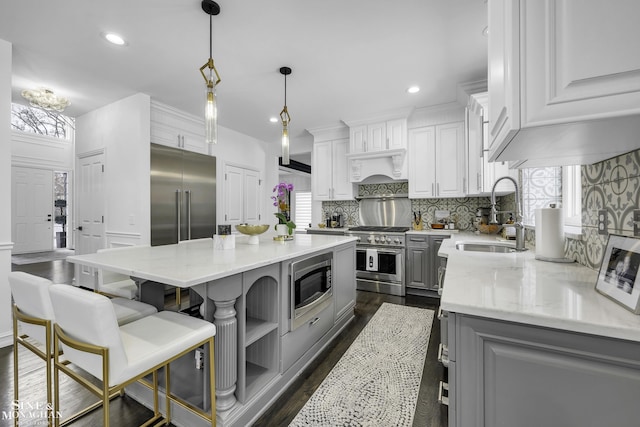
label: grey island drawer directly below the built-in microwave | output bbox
[281,302,334,372]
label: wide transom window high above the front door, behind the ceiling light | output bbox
[11,103,75,140]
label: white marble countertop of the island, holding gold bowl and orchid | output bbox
[67,233,356,288]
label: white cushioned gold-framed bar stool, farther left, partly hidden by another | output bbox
[8,271,157,425]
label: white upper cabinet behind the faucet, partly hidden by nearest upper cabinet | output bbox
[466,92,518,196]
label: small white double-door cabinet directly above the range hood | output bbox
[349,119,407,153]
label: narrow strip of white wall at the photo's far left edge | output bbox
[0,40,13,347]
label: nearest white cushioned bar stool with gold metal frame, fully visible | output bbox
[49,285,216,426]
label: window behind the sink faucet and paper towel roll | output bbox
[522,165,582,227]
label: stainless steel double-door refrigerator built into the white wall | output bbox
[151,144,216,246]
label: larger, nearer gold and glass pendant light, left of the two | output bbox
[200,0,220,144]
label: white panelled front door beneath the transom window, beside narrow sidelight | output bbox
[11,167,53,254]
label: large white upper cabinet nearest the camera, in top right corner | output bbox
[488,0,640,166]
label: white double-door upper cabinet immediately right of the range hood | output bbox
[408,122,466,199]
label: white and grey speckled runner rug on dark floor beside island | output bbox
[290,303,434,427]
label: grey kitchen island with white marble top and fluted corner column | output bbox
[68,235,355,427]
